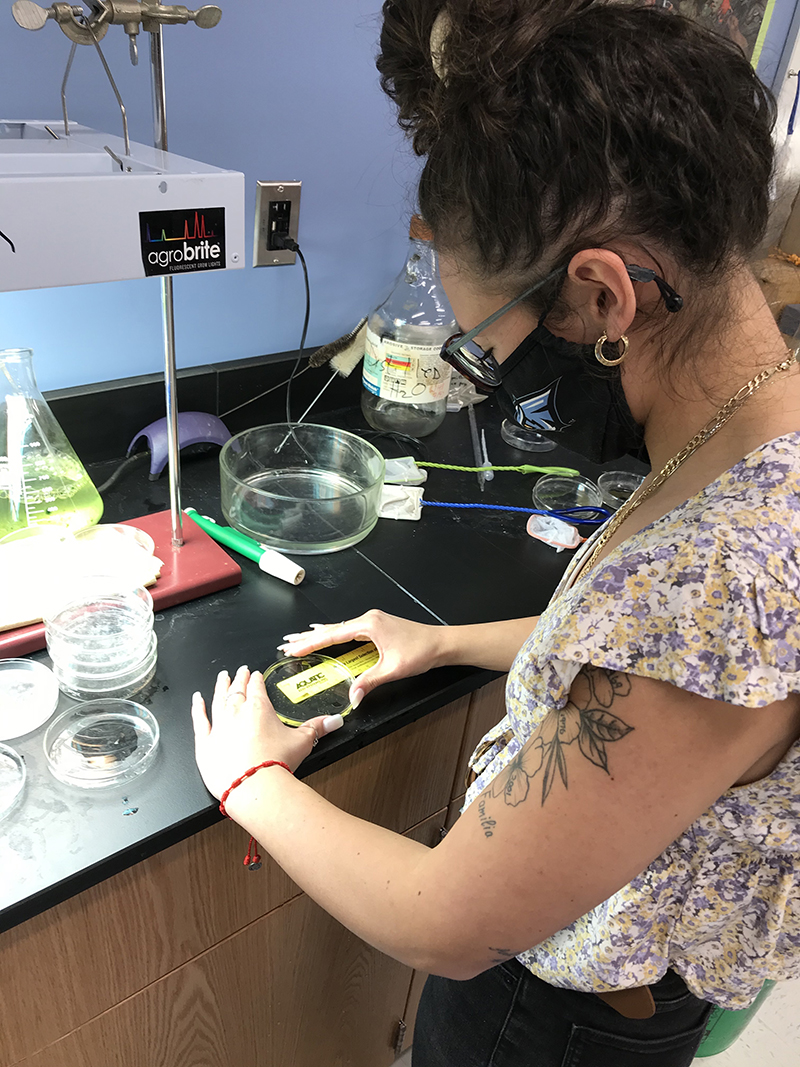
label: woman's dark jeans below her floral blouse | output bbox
[412,959,711,1067]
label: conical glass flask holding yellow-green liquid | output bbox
[0,348,102,538]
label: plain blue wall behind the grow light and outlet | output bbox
[0,0,418,389]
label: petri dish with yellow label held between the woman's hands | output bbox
[263,652,355,727]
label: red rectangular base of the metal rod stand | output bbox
[0,511,242,659]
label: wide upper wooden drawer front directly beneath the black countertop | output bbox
[0,697,469,1067]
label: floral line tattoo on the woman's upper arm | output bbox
[477,664,634,838]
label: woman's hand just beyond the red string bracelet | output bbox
[192,667,342,799]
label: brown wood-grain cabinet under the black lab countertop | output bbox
[0,683,501,1067]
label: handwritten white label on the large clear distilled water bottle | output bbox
[364,330,450,403]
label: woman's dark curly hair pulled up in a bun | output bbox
[378,0,774,315]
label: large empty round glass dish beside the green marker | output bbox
[220,423,384,555]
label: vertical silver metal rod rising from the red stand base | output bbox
[150,18,183,547]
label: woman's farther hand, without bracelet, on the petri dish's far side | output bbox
[278,608,444,707]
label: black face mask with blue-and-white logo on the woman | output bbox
[497,324,646,463]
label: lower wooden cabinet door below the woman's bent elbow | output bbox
[16,810,446,1067]
